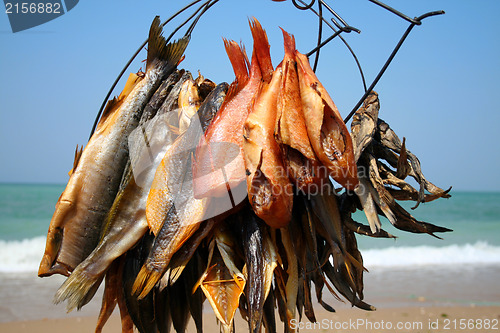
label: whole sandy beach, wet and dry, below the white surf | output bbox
[0,265,500,333]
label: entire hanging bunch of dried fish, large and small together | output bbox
[39,19,450,332]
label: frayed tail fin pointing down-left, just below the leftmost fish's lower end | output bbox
[54,269,102,312]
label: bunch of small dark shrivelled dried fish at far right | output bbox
[350,92,451,238]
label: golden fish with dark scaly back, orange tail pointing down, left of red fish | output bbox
[133,84,227,298]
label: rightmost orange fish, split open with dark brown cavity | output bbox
[295,46,358,190]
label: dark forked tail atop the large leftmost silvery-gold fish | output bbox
[146,16,189,72]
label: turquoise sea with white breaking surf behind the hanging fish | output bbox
[0,184,500,272]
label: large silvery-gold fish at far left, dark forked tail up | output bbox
[38,18,188,276]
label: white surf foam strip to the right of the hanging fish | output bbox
[360,242,500,268]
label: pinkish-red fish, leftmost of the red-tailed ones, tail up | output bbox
[193,21,262,205]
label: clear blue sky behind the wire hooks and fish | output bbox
[0,0,500,191]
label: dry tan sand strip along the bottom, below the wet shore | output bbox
[0,306,500,333]
